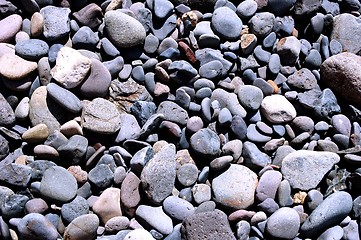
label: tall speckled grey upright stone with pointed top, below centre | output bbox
[140,144,176,204]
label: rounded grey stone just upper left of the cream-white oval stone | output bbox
[238,85,263,110]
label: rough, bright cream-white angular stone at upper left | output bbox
[51,47,91,89]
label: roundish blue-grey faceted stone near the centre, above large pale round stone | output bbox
[190,128,221,158]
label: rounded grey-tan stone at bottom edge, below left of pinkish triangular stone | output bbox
[64,214,99,240]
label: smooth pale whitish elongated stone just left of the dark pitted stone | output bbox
[135,205,173,235]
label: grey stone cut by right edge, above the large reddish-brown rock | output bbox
[330,13,361,54]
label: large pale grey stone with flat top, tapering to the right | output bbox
[281,150,340,191]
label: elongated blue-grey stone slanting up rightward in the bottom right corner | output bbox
[300,192,352,237]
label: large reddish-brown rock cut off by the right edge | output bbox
[321,53,361,106]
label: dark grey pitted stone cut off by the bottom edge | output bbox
[181,210,236,240]
